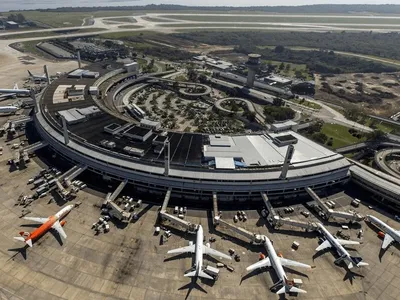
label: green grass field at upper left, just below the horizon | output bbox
[3,10,141,27]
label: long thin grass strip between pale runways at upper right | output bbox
[164,15,399,25]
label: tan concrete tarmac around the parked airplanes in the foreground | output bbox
[0,137,400,300]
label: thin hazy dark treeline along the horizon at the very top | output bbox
[9,4,400,14]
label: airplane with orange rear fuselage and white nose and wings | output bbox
[14,205,74,247]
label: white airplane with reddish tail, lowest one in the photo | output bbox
[246,236,312,294]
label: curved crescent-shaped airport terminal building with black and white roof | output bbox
[34,66,362,201]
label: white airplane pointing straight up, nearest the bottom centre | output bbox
[168,225,232,279]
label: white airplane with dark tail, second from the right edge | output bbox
[315,223,368,269]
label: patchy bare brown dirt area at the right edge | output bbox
[315,73,400,117]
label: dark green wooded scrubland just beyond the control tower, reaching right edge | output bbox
[173,31,400,59]
